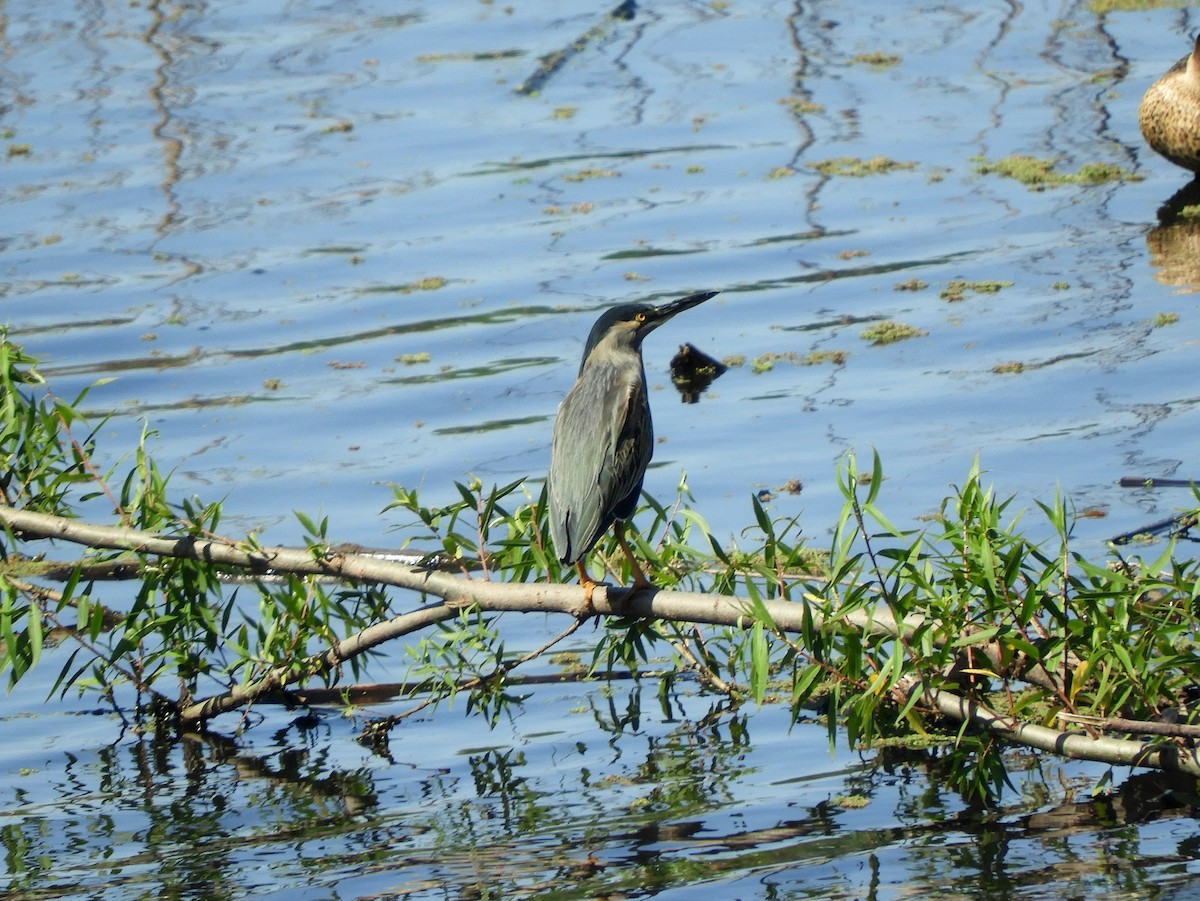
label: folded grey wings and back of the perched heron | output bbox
[548,366,653,563]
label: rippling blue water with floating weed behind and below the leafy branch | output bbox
[0,0,1200,901]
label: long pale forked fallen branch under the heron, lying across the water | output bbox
[0,506,1200,775]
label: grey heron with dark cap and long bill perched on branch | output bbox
[547,292,718,599]
